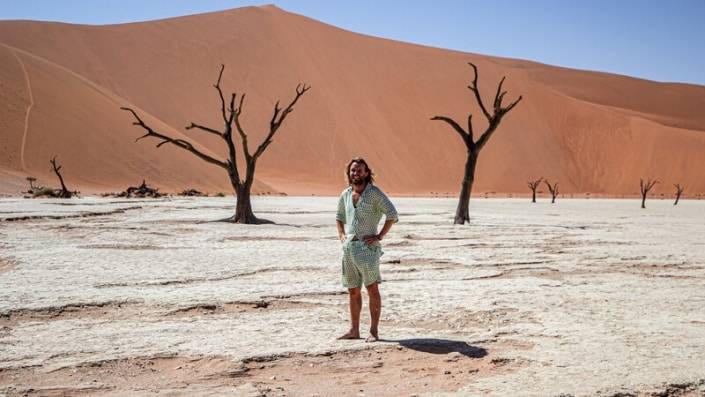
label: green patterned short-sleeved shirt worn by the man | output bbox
[335,183,399,241]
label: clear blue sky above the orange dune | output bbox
[0,0,705,85]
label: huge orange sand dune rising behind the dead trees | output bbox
[0,6,705,196]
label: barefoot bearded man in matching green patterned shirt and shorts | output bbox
[336,158,399,342]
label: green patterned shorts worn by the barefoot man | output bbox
[342,240,382,288]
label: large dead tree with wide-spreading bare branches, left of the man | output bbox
[121,65,311,224]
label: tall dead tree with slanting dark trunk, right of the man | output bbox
[431,62,521,225]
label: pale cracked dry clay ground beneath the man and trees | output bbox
[0,197,705,396]
